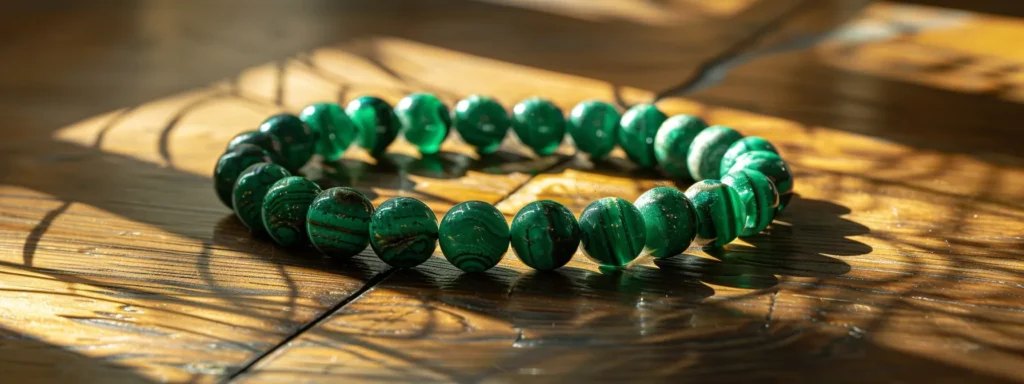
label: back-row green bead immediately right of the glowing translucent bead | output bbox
[452,94,512,155]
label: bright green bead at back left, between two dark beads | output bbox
[299,102,357,162]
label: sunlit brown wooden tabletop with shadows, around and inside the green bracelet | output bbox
[0,0,1024,383]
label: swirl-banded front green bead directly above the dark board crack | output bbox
[370,197,437,268]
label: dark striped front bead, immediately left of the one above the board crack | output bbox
[306,186,374,257]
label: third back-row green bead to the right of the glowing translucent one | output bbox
[565,100,620,159]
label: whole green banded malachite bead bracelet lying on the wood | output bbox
[214,93,793,272]
